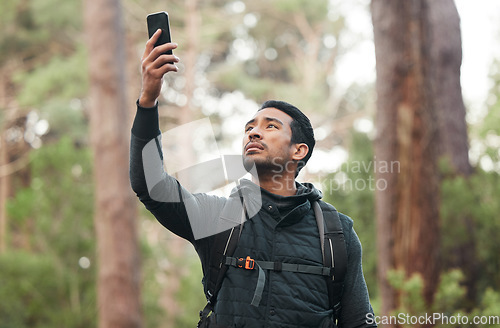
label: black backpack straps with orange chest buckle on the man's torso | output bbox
[197,201,347,328]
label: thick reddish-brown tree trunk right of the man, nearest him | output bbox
[371,0,439,314]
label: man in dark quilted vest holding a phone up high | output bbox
[130,31,373,328]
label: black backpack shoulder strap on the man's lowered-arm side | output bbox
[312,201,347,319]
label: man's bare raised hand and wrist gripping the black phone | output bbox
[139,30,179,107]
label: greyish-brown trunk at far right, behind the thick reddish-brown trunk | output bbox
[429,0,479,305]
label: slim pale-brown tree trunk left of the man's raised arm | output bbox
[84,0,142,328]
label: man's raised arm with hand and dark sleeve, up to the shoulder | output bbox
[130,31,238,243]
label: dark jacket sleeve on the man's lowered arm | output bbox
[339,214,377,328]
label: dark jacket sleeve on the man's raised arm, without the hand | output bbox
[129,105,226,244]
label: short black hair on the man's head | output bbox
[259,100,316,176]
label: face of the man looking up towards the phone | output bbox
[243,108,294,174]
